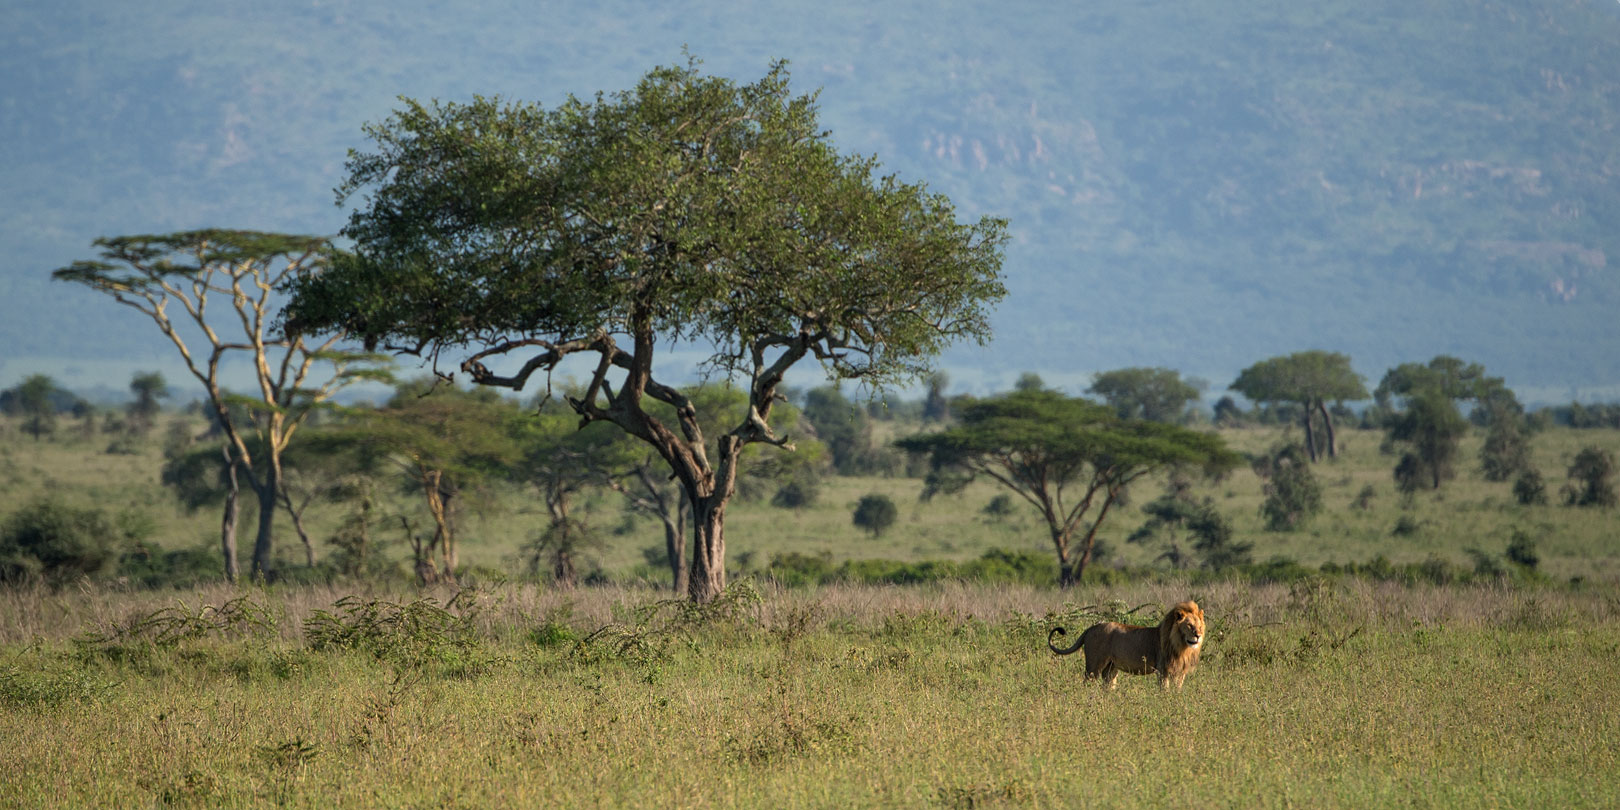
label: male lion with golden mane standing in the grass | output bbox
[1047,599,1204,689]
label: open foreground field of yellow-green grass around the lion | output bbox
[0,580,1620,808]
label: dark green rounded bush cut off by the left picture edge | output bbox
[0,497,130,583]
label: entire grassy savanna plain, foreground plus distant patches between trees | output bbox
[0,414,1620,807]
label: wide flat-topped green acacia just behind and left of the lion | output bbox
[896,390,1239,586]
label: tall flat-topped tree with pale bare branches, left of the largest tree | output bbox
[53,230,379,582]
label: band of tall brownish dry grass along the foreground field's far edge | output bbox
[0,578,1620,645]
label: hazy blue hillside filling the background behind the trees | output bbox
[0,0,1620,398]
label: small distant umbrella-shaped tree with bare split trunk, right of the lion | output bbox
[1231,350,1367,462]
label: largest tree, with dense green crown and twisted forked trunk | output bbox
[290,62,1006,601]
